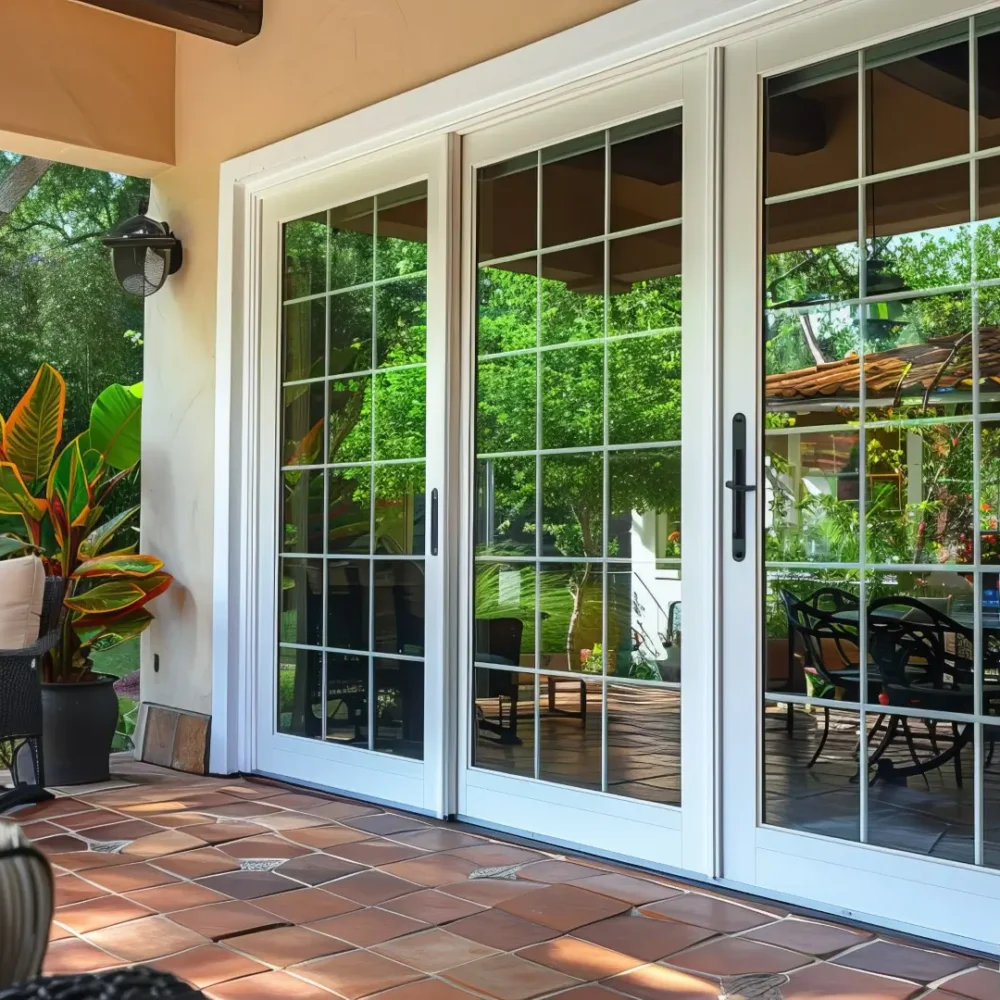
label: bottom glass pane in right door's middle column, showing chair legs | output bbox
[868,715,976,865]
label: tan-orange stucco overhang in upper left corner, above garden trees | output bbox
[0,0,175,174]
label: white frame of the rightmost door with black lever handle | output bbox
[722,0,1000,951]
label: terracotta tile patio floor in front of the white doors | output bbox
[3,761,1000,1000]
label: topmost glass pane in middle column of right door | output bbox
[865,21,969,174]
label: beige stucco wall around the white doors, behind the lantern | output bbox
[142,0,629,712]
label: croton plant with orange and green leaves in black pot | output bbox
[0,365,173,683]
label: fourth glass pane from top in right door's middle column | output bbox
[866,423,975,564]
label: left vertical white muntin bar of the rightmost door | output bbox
[858,49,869,844]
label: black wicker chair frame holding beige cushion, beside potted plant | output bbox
[0,576,65,813]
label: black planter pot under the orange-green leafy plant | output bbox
[42,677,118,785]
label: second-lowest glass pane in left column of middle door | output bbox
[473,562,536,668]
